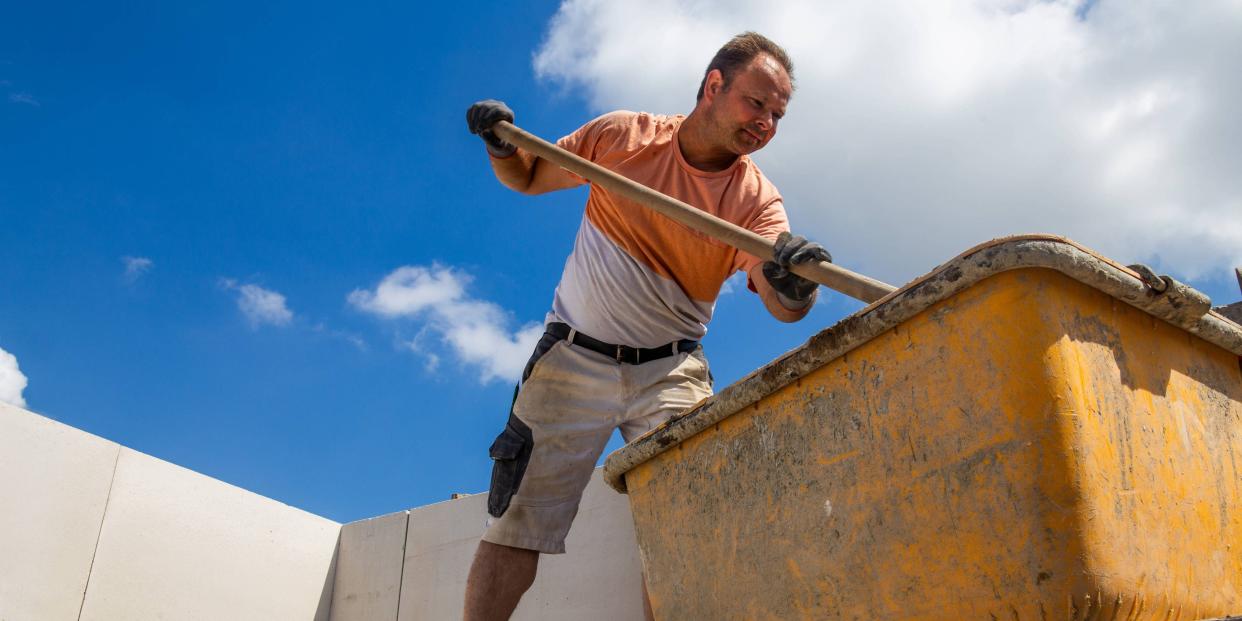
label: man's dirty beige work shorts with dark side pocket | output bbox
[483,334,712,554]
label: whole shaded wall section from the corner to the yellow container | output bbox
[332,471,642,621]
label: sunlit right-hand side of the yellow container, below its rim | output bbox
[1046,278,1242,619]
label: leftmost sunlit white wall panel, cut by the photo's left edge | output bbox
[0,404,120,621]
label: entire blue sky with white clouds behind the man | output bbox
[0,0,1242,522]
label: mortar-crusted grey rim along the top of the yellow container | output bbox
[604,233,1242,493]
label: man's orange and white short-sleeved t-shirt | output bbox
[549,111,789,347]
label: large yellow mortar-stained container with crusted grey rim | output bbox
[605,236,1242,620]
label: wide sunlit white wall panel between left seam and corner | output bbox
[81,448,340,621]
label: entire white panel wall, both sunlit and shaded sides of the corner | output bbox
[0,404,642,621]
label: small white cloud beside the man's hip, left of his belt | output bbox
[348,265,543,384]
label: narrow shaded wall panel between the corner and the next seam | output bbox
[332,510,410,621]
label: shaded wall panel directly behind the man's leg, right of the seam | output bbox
[400,471,642,621]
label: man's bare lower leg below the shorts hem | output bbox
[465,542,539,621]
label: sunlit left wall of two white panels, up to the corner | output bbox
[0,404,340,621]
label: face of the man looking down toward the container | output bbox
[704,53,794,155]
